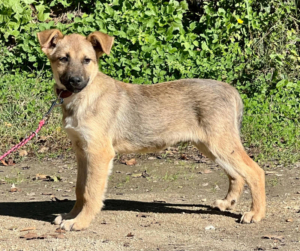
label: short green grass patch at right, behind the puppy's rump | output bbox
[242,81,300,162]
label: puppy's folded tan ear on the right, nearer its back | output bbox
[87,31,115,58]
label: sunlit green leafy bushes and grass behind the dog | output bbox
[0,0,300,162]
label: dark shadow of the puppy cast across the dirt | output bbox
[0,199,241,222]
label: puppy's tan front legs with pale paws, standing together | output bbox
[54,140,114,230]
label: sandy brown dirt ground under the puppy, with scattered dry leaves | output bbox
[0,157,300,251]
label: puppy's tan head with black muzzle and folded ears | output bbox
[37,29,114,93]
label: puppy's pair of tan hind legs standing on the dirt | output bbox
[196,133,266,223]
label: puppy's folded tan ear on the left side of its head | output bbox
[37,29,64,55]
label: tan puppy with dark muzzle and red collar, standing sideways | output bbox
[37,29,266,230]
